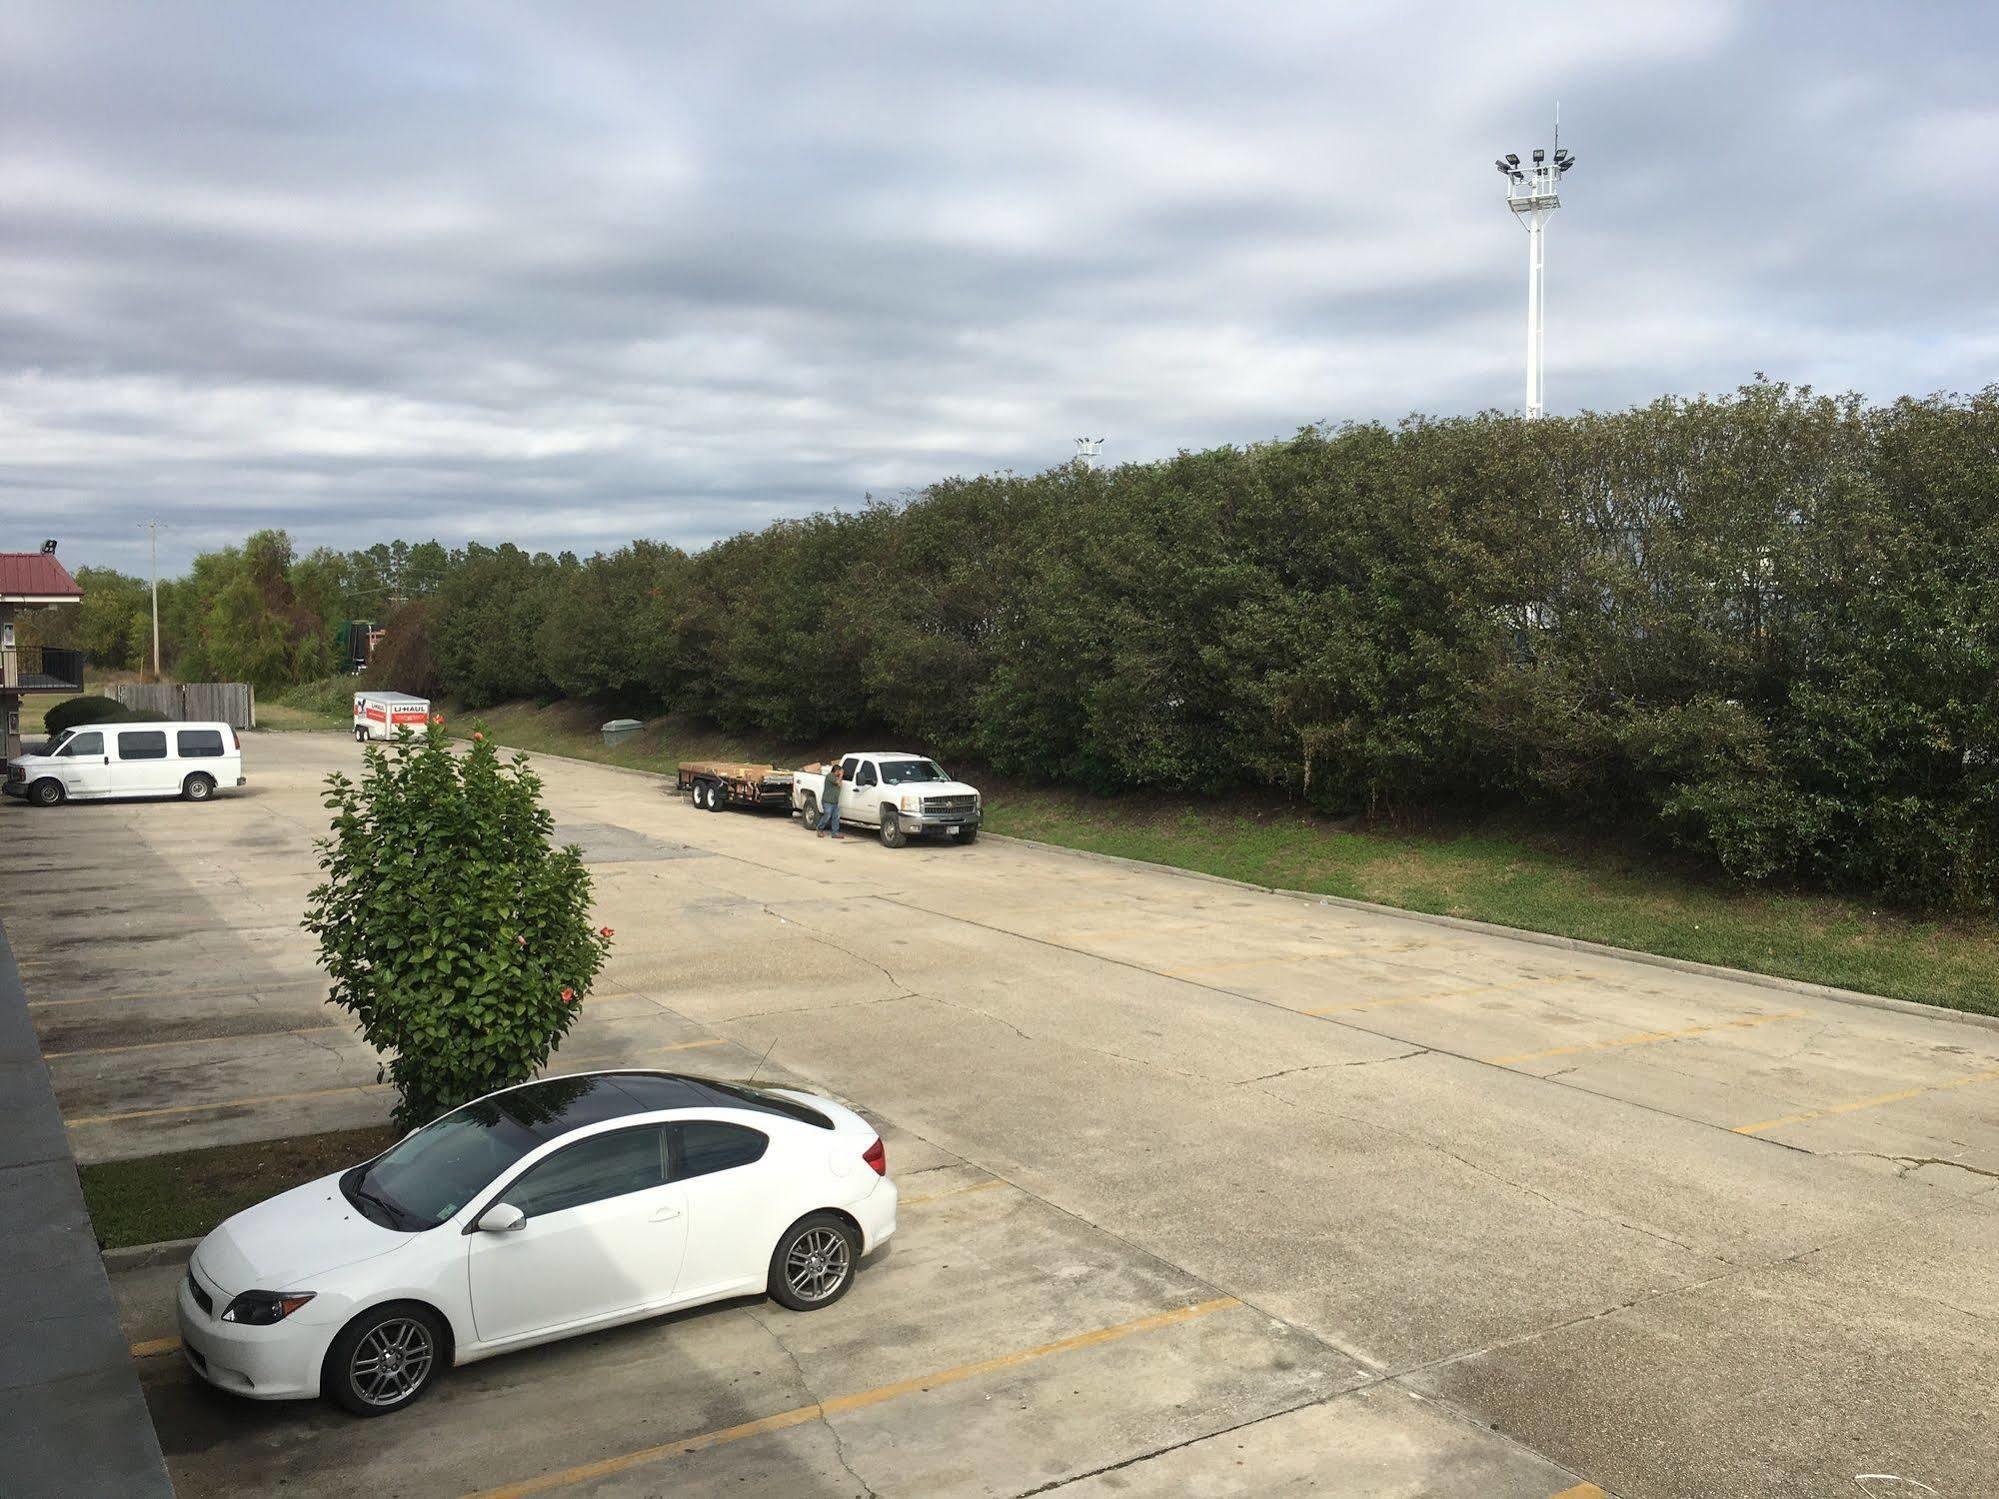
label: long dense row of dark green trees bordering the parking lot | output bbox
[50,382,1999,909]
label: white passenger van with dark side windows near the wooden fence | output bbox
[0,724,244,807]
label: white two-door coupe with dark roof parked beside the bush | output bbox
[180,1071,896,1415]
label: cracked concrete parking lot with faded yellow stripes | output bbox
[0,734,1999,1499]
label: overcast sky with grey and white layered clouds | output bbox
[0,0,1999,570]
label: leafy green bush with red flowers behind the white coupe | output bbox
[302,718,612,1127]
